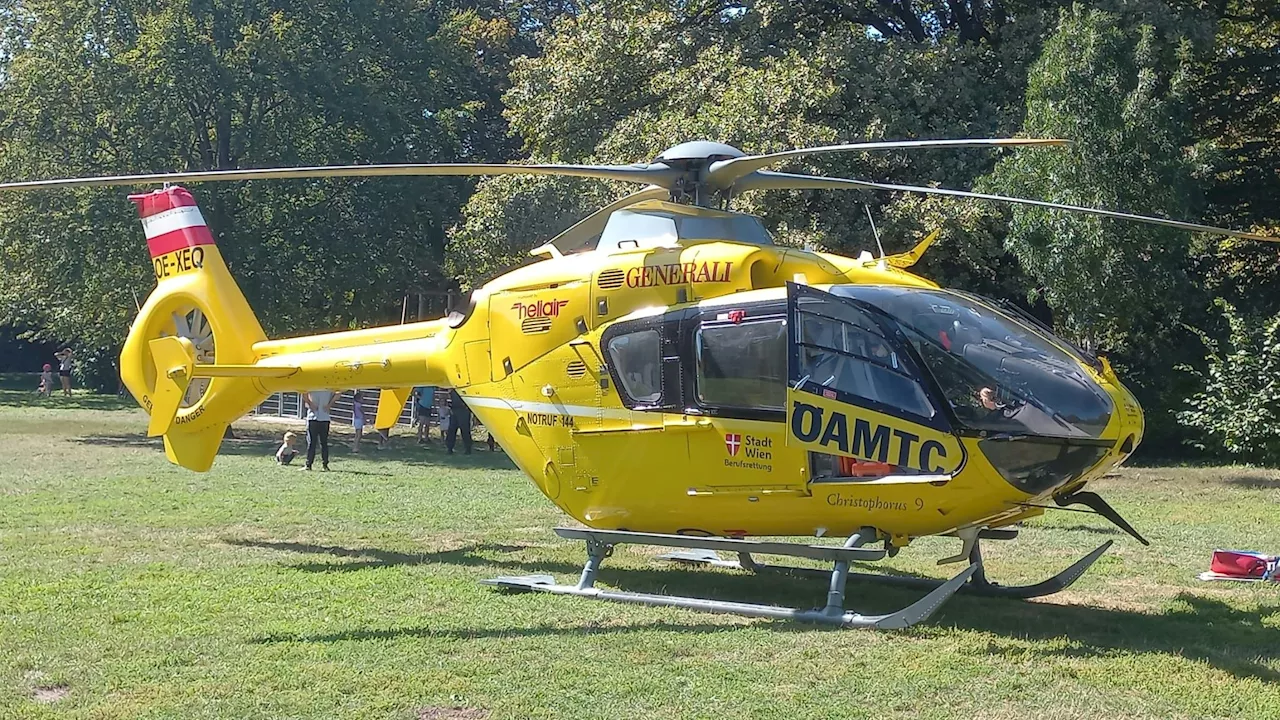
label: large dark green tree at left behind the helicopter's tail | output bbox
[0,0,529,389]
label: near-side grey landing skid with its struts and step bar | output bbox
[483,528,982,630]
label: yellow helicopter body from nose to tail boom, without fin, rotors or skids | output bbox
[227,199,1142,544]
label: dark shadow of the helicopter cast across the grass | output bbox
[224,539,1280,683]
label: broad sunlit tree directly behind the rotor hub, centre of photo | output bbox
[451,0,1042,295]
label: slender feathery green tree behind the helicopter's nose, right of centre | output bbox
[984,6,1203,351]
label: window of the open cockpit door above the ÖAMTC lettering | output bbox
[796,302,934,418]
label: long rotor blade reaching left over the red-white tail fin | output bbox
[0,163,680,190]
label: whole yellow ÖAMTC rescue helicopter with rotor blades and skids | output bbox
[0,138,1275,628]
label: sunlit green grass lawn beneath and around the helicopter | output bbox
[0,379,1280,720]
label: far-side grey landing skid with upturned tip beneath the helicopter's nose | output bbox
[658,536,1114,600]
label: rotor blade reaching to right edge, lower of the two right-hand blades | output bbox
[735,170,1280,242]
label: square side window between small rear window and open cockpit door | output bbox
[694,318,787,410]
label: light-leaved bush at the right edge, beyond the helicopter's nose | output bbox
[1178,299,1280,464]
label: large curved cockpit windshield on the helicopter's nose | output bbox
[831,286,1114,438]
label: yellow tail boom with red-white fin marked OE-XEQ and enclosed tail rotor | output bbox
[120,186,467,471]
